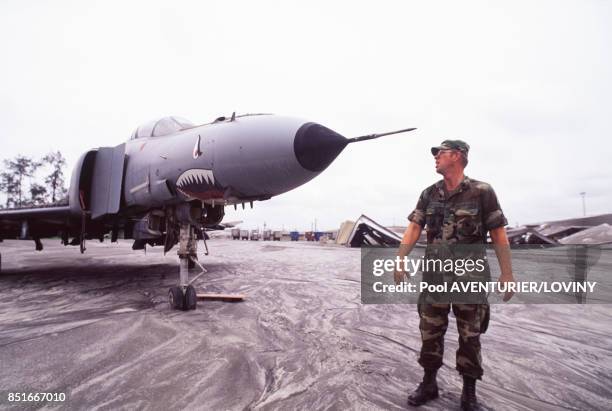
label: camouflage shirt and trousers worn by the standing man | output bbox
[408,177,507,379]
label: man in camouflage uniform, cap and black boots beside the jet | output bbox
[395,140,514,410]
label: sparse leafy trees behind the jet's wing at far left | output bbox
[0,151,67,208]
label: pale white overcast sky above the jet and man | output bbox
[0,0,612,230]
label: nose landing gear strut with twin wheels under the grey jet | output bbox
[168,224,205,311]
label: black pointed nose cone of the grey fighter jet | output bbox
[293,123,348,172]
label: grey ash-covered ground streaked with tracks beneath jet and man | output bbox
[0,239,612,410]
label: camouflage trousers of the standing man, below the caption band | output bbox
[419,304,489,379]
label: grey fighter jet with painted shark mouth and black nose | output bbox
[0,113,414,310]
